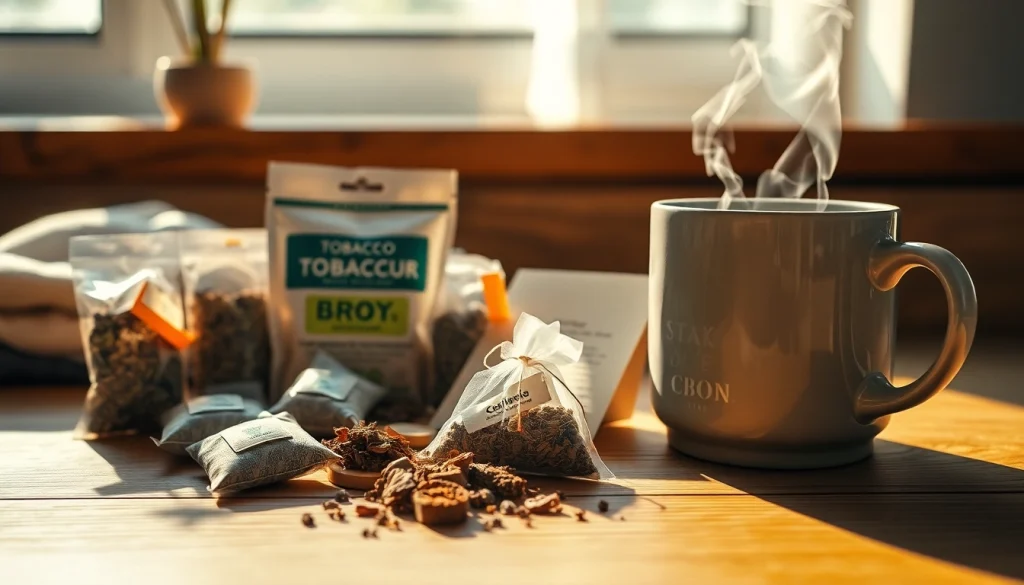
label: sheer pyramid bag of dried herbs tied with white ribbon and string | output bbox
[420,312,611,478]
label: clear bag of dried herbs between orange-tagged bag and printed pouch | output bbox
[181,229,270,404]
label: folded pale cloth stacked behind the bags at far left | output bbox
[0,201,221,383]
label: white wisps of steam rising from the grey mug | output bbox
[692,0,853,208]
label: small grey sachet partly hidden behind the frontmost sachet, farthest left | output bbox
[153,394,263,455]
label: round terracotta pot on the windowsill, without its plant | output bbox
[154,57,256,128]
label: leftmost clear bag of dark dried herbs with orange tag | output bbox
[69,232,189,438]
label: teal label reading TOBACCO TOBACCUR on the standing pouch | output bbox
[286,234,427,291]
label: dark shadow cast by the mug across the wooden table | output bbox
[686,441,1024,579]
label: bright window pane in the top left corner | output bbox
[0,0,103,35]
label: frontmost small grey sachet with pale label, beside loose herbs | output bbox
[187,413,338,494]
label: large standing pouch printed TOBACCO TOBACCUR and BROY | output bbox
[266,163,457,402]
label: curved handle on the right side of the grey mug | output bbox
[854,239,978,424]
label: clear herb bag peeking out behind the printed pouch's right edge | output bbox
[427,249,505,408]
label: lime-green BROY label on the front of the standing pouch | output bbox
[306,295,409,335]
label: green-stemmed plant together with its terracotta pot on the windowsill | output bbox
[154,0,256,128]
